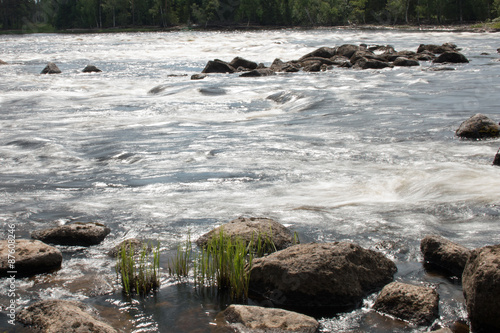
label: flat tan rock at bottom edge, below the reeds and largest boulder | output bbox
[216,304,319,333]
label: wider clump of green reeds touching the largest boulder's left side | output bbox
[169,228,276,300]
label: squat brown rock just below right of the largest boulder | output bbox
[373,282,439,325]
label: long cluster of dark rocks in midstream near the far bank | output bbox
[192,43,469,79]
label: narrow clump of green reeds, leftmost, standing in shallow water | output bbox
[116,242,160,296]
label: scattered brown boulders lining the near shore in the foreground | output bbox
[0,208,500,333]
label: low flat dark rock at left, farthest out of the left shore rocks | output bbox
[31,222,111,246]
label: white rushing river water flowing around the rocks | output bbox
[0,30,500,332]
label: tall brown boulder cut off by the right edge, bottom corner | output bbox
[462,245,500,333]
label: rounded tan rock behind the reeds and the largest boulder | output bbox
[196,217,293,250]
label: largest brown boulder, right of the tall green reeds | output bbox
[250,242,397,313]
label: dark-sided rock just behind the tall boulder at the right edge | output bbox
[420,236,470,277]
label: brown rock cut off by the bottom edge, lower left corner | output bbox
[16,300,117,333]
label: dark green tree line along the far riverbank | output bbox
[0,0,500,30]
